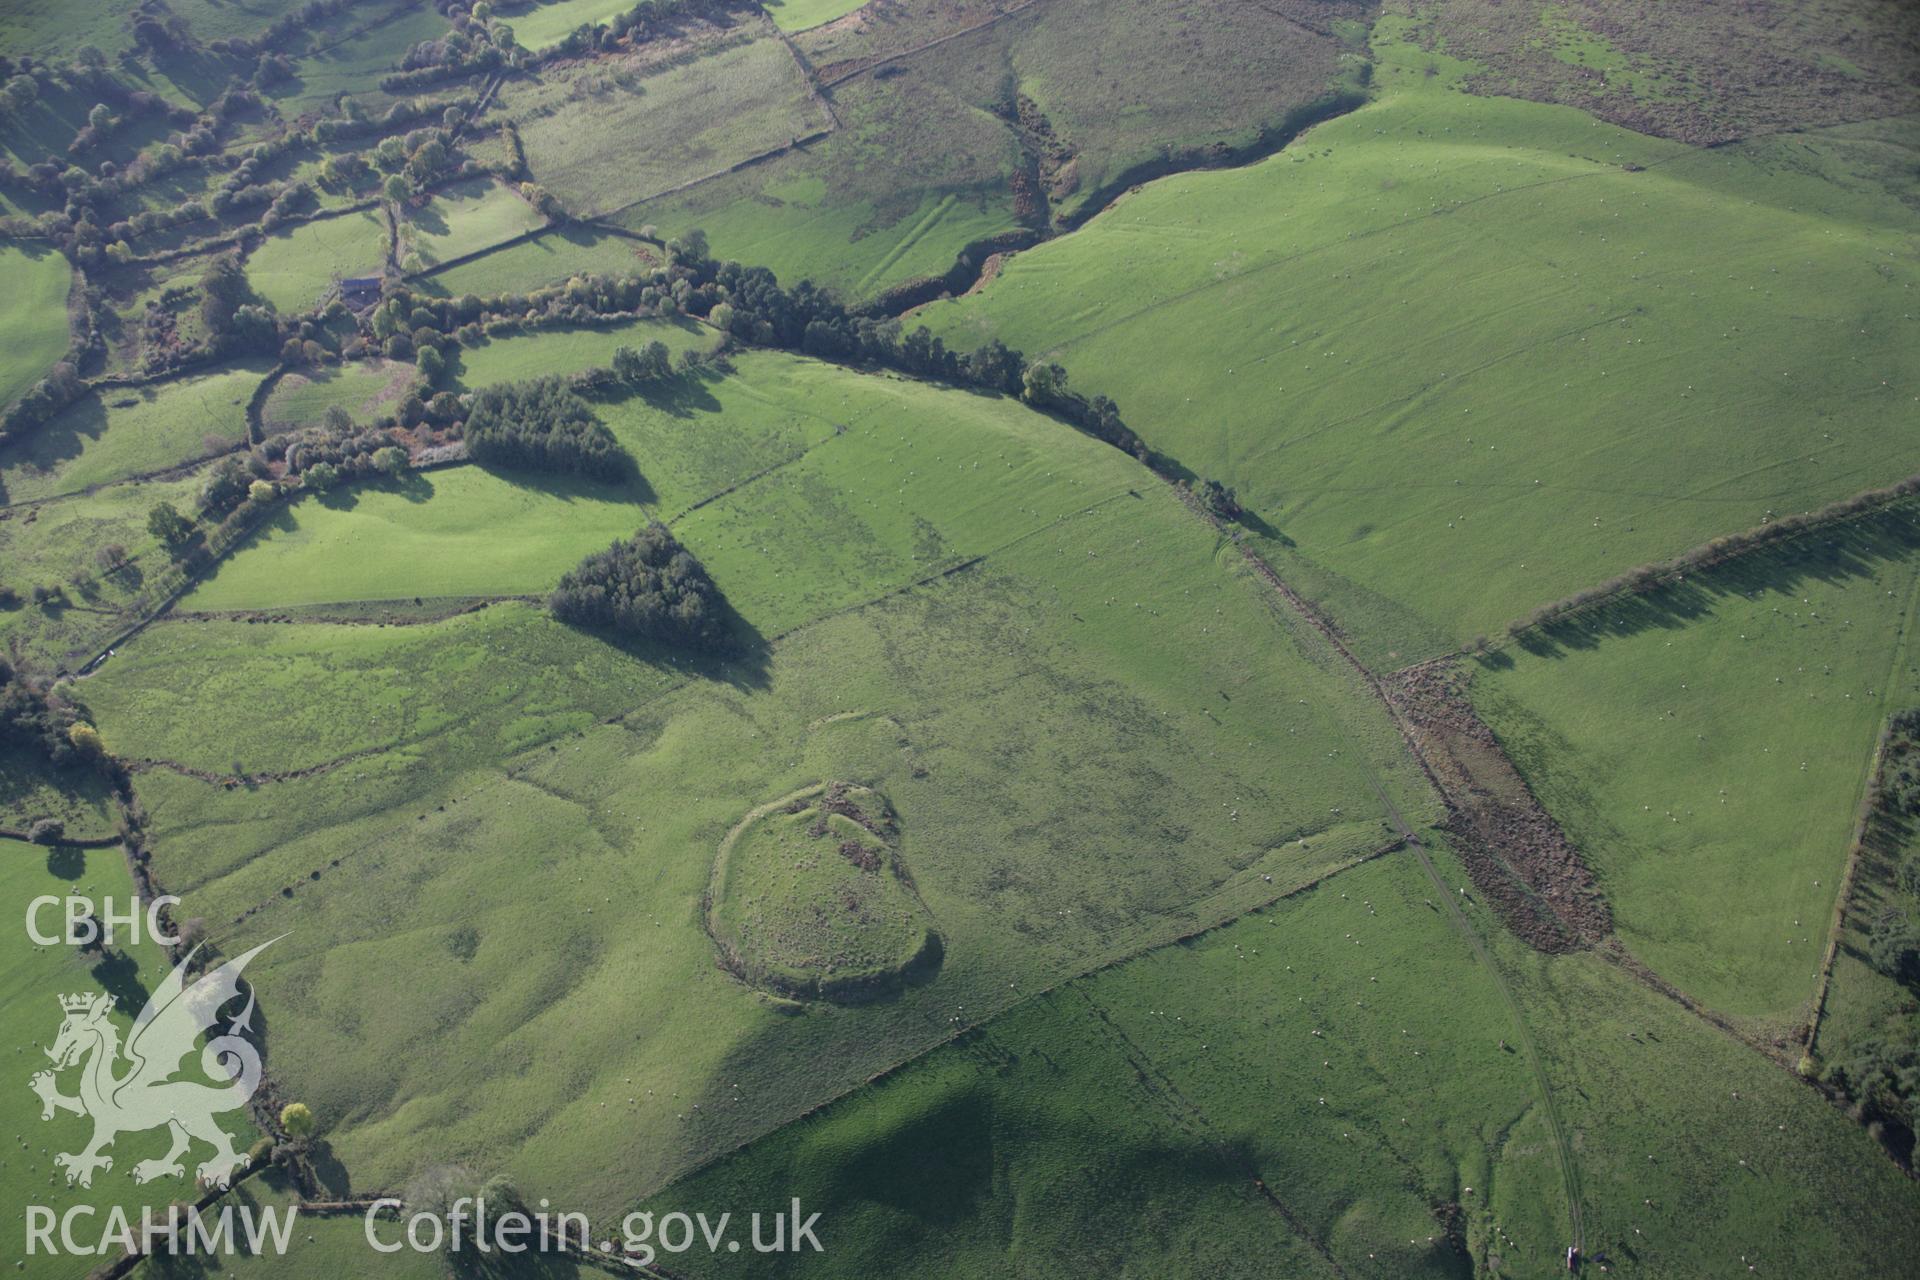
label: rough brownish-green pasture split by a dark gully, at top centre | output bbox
[618,0,1338,299]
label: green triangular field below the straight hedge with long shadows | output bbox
[1473,507,1920,1031]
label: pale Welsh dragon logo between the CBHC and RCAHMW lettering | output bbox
[31,938,278,1188]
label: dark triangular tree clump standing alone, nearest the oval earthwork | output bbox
[547,522,726,649]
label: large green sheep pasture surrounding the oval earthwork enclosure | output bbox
[84,343,1430,1213]
